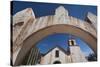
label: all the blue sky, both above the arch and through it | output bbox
[12,1,97,55]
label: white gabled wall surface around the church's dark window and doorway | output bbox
[40,47,70,64]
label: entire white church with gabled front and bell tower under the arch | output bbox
[40,40,87,64]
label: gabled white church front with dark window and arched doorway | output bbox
[40,47,71,64]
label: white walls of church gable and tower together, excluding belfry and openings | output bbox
[40,45,87,64]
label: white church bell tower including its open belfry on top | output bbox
[68,38,87,62]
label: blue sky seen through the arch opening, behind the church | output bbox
[37,33,93,55]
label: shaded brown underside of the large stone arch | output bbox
[14,24,97,65]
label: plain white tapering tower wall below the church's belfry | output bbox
[70,45,87,62]
